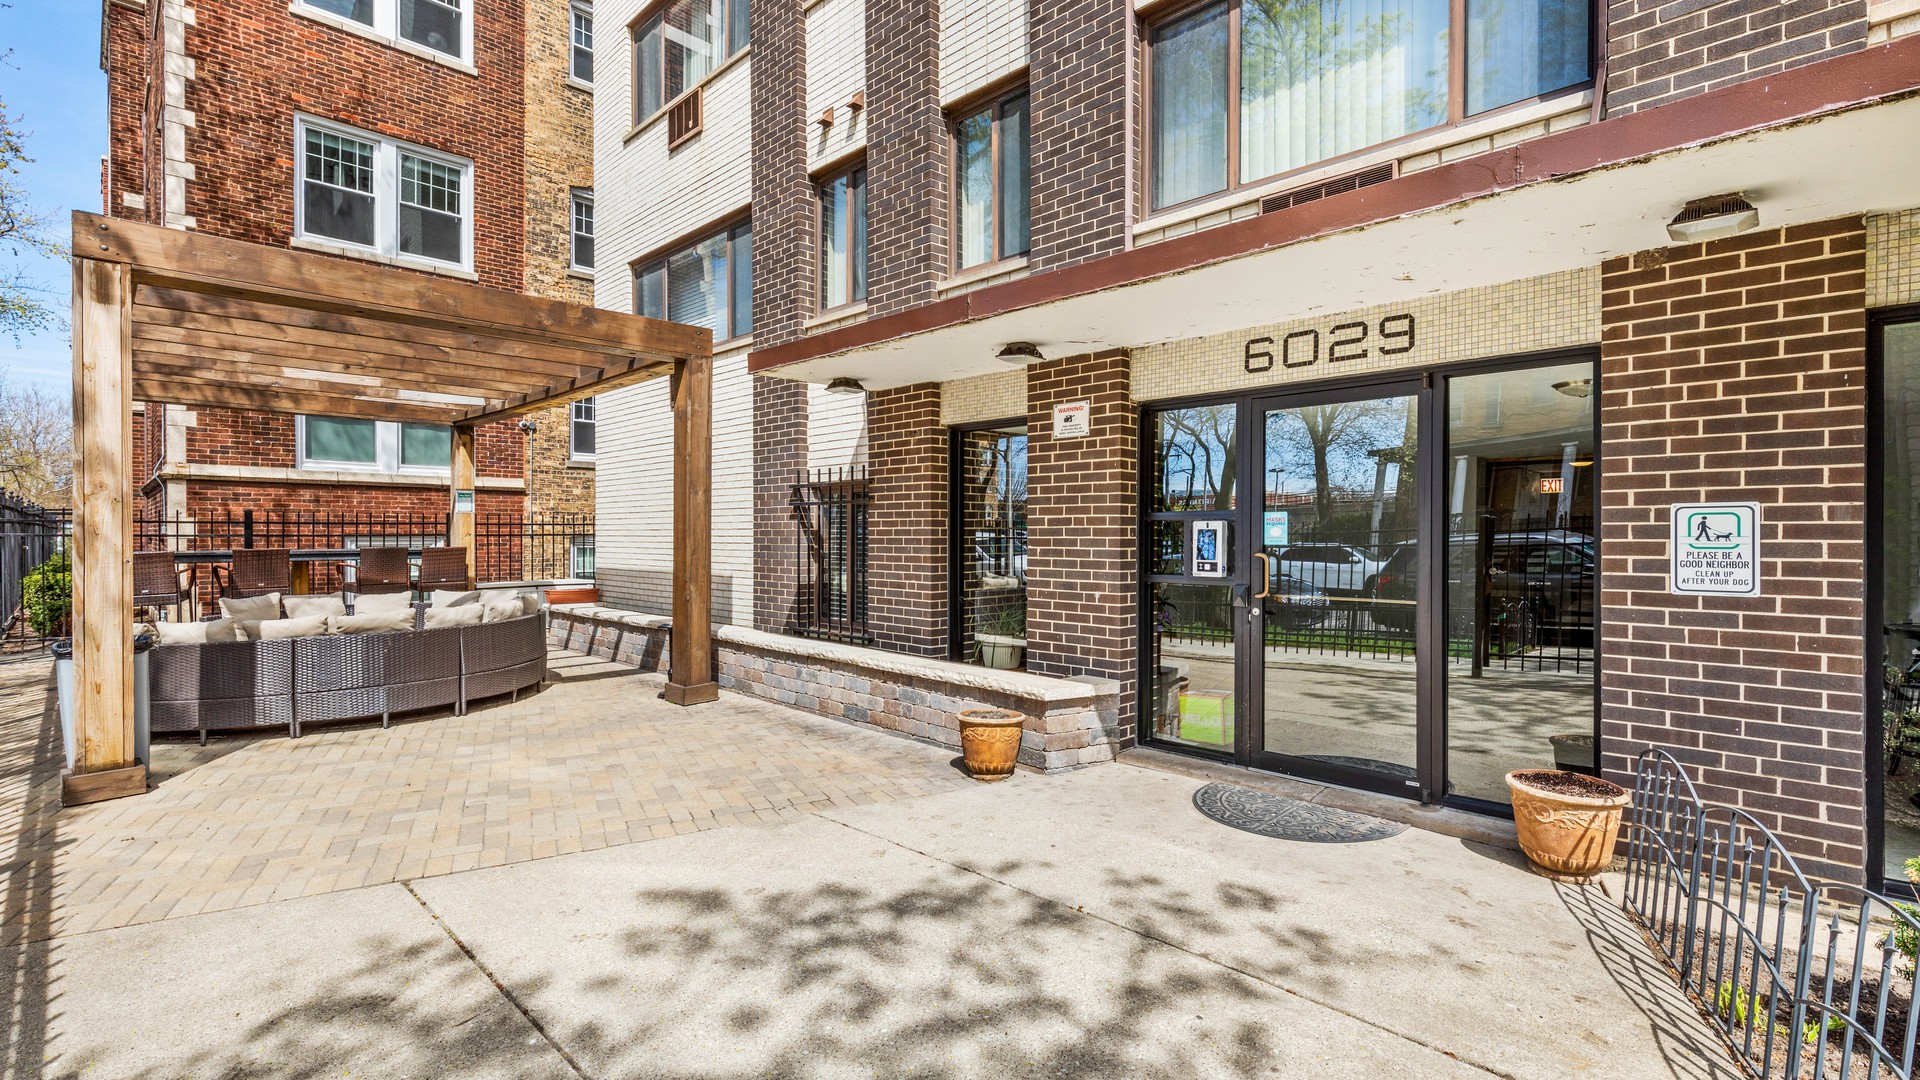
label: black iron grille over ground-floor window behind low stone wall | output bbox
[789,467,872,642]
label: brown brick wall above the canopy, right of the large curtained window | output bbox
[1607,0,1866,115]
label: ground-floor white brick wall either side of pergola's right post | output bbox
[593,340,753,626]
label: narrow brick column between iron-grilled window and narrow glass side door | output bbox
[866,382,947,655]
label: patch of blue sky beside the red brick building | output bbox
[0,0,108,394]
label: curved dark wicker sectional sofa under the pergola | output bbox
[148,611,547,742]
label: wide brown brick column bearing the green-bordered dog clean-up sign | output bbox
[1599,217,1872,882]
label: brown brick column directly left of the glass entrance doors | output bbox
[1027,352,1140,745]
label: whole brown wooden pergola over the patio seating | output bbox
[61,213,718,805]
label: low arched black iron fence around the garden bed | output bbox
[1622,749,1920,1080]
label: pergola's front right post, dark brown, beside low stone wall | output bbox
[666,354,720,705]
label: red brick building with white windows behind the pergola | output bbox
[102,0,593,577]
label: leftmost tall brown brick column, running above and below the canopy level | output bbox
[749,0,814,632]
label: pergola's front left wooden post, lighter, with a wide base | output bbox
[60,258,146,805]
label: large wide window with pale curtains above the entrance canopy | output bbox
[1148,0,1592,209]
